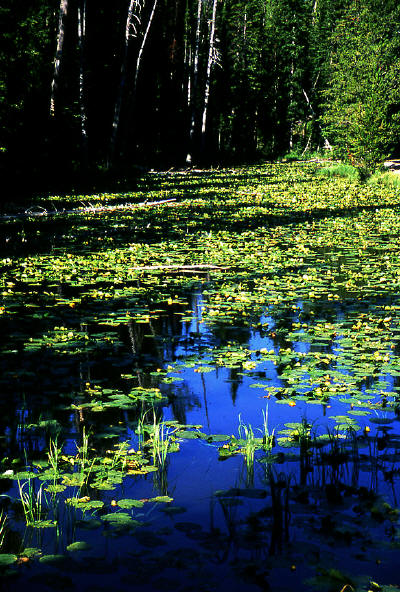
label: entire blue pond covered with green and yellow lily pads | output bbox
[0,163,400,592]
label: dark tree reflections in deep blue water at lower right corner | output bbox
[194,431,399,590]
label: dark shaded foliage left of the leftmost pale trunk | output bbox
[0,0,54,171]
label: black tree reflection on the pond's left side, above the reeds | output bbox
[0,288,206,459]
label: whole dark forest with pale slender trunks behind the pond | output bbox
[0,0,400,196]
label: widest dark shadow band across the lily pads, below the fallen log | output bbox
[0,195,399,258]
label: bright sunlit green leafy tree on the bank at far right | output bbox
[322,2,400,175]
